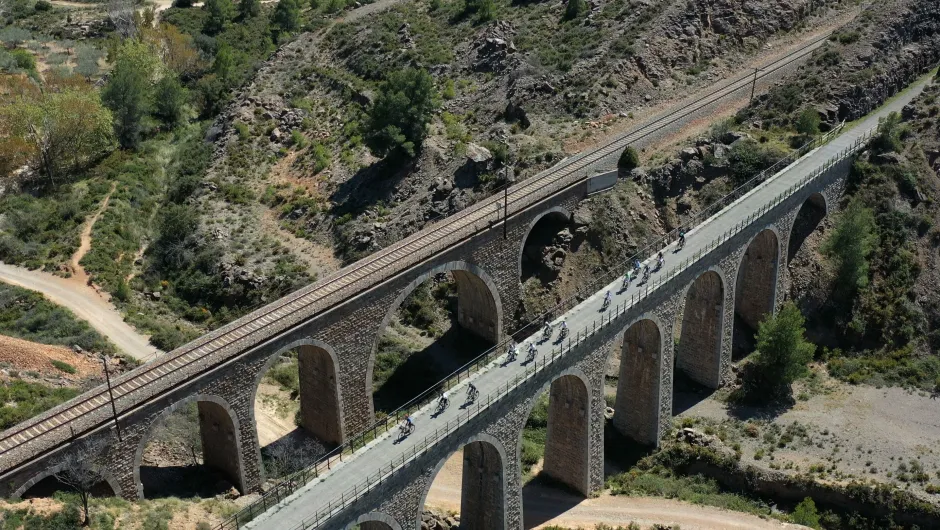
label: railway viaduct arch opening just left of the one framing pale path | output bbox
[138,400,244,499]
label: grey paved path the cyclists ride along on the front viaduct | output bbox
[247,75,927,530]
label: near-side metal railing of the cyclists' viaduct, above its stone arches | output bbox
[280,130,873,530]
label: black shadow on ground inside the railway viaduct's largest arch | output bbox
[372,322,492,413]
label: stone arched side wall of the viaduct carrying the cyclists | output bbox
[290,154,852,530]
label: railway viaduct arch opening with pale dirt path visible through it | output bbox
[254,344,343,480]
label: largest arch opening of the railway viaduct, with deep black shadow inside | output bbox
[372,269,502,417]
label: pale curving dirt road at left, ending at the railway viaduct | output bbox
[0,263,161,361]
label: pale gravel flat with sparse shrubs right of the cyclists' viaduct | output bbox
[680,368,940,502]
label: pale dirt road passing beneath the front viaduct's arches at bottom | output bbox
[426,451,804,530]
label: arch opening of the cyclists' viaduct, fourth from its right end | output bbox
[614,314,672,445]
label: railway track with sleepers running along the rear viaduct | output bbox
[0,31,828,473]
